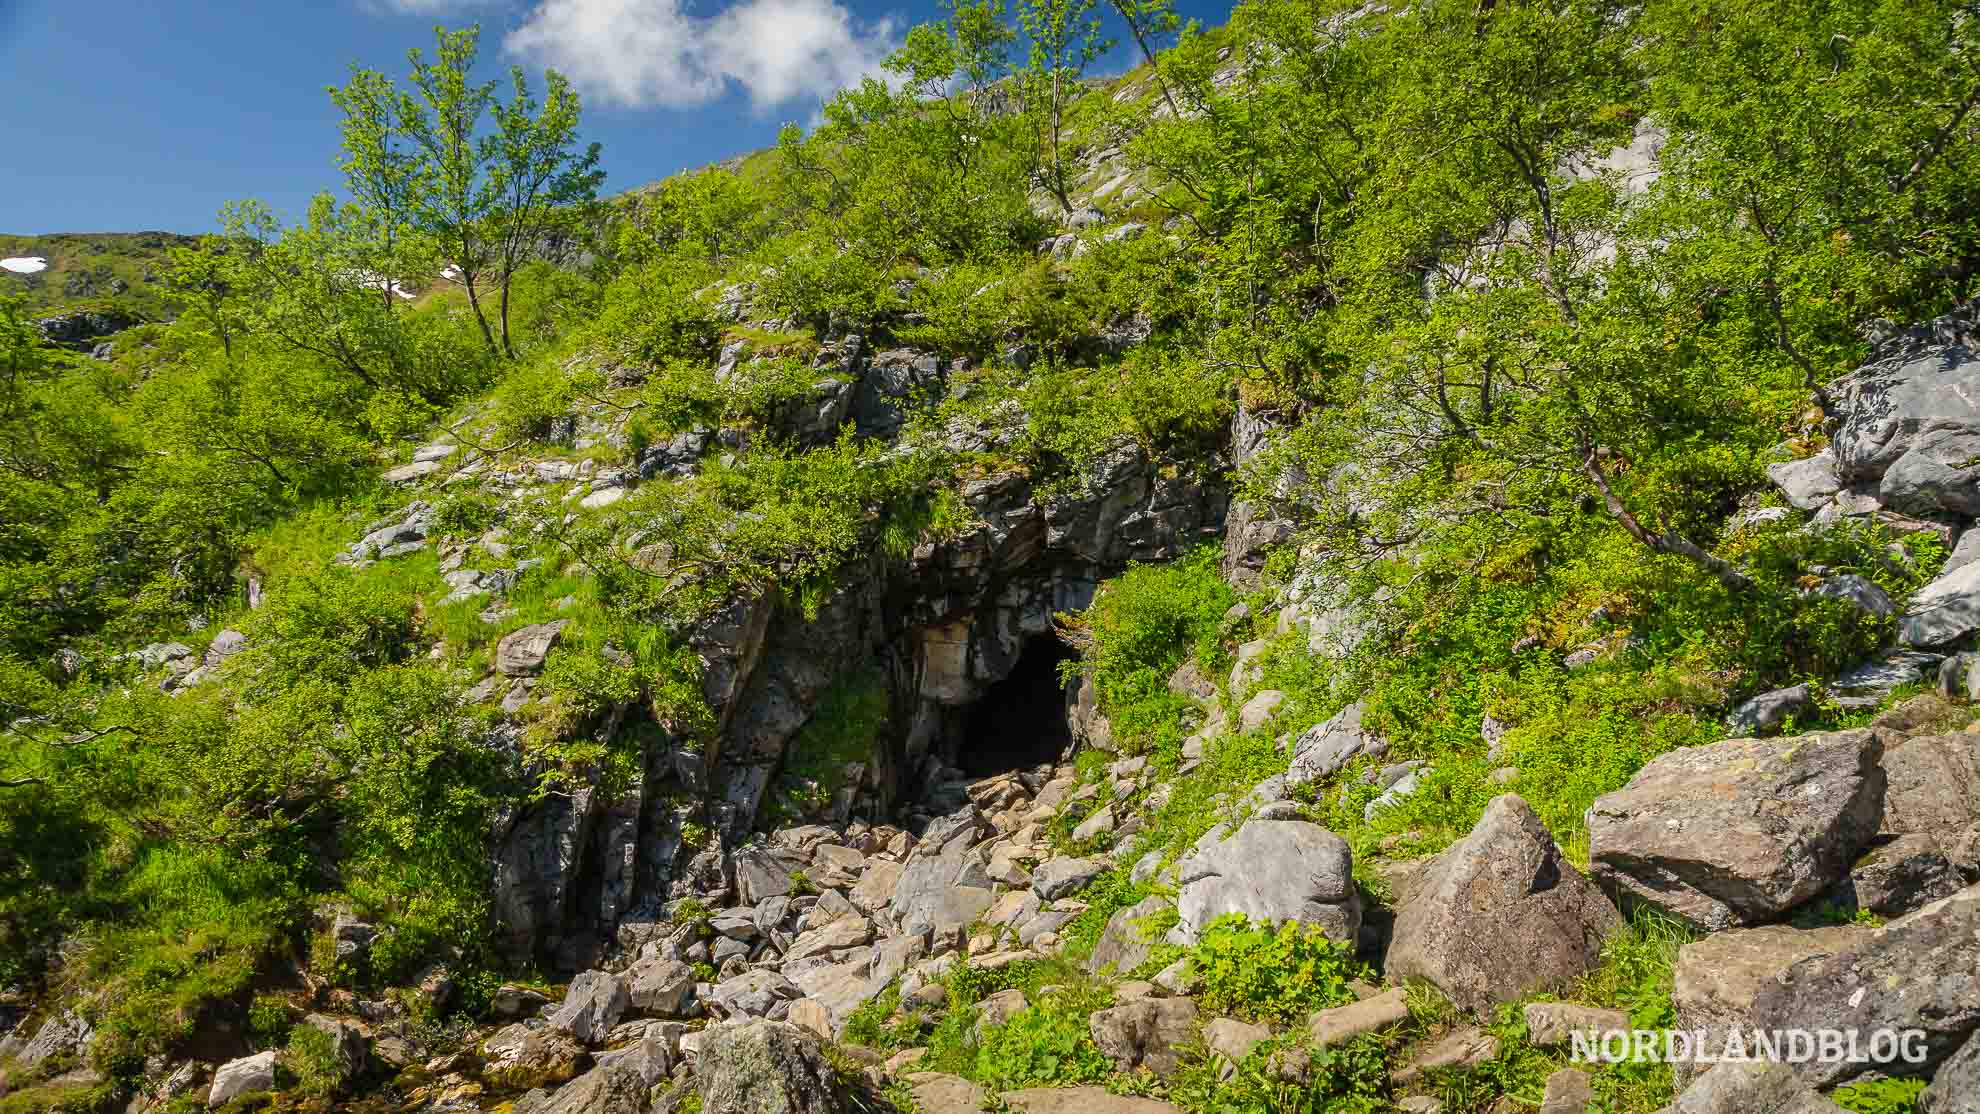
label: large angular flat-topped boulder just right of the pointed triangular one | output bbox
[1588,730,1885,932]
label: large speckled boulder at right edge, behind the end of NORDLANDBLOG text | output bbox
[1750,884,1980,1088]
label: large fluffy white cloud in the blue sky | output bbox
[503,0,895,109]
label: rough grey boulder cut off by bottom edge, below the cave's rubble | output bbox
[695,1021,849,1114]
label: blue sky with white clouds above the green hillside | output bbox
[0,0,1230,233]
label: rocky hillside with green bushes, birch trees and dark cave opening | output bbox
[0,0,1980,1114]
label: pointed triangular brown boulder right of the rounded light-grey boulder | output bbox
[1388,793,1622,1013]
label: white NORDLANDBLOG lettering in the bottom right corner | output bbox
[1570,1029,1927,1065]
